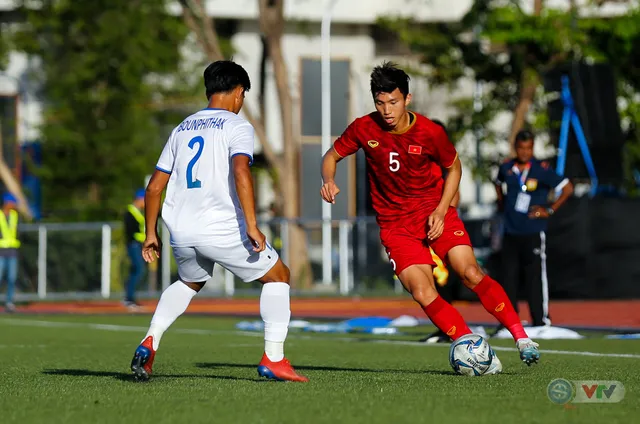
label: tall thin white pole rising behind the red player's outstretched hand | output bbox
[320,0,337,284]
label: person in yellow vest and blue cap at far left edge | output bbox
[0,193,20,312]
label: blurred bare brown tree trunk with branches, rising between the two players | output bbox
[180,0,312,287]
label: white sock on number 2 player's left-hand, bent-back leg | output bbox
[142,280,198,350]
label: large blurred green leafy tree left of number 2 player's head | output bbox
[15,0,187,220]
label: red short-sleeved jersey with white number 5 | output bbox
[333,112,457,231]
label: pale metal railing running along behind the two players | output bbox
[5,217,486,301]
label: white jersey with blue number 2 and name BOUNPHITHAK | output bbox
[156,108,254,247]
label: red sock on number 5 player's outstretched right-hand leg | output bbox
[473,275,529,341]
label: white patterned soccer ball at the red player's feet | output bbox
[449,334,493,376]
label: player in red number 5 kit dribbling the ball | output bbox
[320,62,540,373]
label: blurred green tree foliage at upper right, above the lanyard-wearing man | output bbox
[380,0,640,189]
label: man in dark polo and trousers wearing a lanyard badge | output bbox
[496,130,573,326]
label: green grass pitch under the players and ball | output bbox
[0,315,640,424]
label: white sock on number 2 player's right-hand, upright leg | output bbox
[260,283,291,362]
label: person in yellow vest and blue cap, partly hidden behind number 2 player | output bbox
[124,189,145,309]
